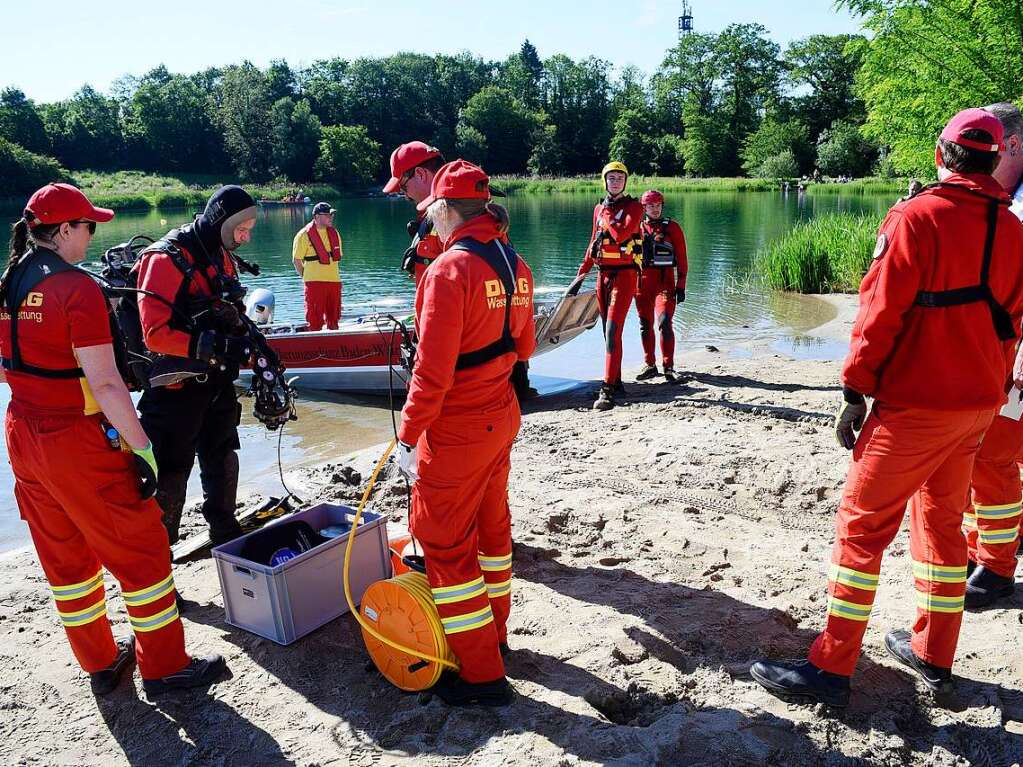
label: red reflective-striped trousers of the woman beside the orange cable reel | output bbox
[409,396,520,682]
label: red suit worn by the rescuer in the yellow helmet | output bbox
[577,196,643,387]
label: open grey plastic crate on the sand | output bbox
[213,503,391,644]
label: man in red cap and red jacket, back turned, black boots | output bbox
[750,109,1023,707]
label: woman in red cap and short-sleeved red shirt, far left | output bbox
[0,184,226,694]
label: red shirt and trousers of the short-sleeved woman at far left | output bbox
[0,256,189,679]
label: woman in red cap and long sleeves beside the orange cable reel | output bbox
[390,160,536,706]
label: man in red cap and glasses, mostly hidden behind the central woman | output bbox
[384,141,444,285]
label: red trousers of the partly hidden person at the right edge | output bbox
[963,415,1023,578]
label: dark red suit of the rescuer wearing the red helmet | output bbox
[636,218,690,368]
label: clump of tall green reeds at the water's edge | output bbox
[753,213,881,292]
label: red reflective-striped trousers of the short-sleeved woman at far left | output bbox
[6,404,189,679]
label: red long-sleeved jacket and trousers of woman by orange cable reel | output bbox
[398,215,536,682]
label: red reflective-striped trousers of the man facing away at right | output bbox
[809,402,993,676]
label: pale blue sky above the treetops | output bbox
[0,0,858,101]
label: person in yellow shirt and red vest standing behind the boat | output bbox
[292,202,344,331]
